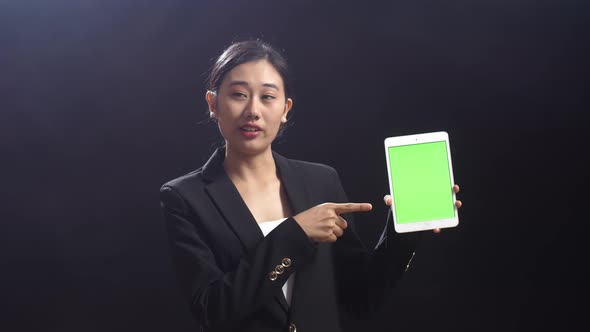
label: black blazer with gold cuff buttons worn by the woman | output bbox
[160,149,417,332]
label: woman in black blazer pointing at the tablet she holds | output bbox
[160,41,461,332]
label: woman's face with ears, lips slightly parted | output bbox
[206,60,293,155]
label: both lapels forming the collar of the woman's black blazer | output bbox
[202,148,310,251]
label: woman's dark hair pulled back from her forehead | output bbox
[207,39,291,98]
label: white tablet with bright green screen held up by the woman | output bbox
[385,131,459,233]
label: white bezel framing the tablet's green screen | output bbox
[384,131,459,233]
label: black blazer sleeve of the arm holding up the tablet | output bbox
[332,171,423,318]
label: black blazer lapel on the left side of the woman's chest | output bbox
[203,148,263,251]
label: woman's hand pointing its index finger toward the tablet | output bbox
[293,203,373,242]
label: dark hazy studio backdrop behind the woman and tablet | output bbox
[0,0,590,331]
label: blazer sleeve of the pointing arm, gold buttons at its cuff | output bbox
[160,186,316,328]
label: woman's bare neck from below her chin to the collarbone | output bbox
[223,147,277,183]
